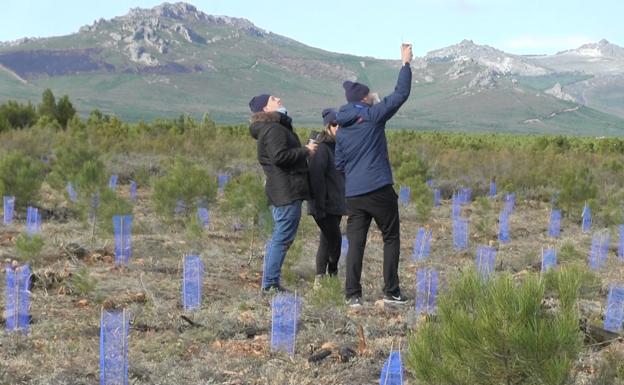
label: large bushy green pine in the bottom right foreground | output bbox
[407,270,582,385]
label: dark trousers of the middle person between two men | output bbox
[314,215,342,275]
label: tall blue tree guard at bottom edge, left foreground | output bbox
[100,309,130,385]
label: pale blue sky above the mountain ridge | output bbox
[0,0,624,59]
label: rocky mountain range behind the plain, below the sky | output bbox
[0,3,624,135]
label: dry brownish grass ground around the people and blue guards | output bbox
[0,181,624,385]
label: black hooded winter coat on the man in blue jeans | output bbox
[249,112,310,206]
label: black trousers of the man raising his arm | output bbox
[345,185,401,298]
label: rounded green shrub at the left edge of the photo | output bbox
[0,151,44,208]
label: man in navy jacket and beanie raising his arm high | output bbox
[335,44,412,307]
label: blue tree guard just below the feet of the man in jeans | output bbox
[271,293,301,356]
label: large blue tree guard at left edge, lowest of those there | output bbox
[5,265,31,334]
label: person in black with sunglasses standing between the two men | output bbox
[308,108,347,287]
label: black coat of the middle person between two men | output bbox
[308,133,347,218]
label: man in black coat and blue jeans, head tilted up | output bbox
[249,94,317,292]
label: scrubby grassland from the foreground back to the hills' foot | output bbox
[0,120,624,385]
